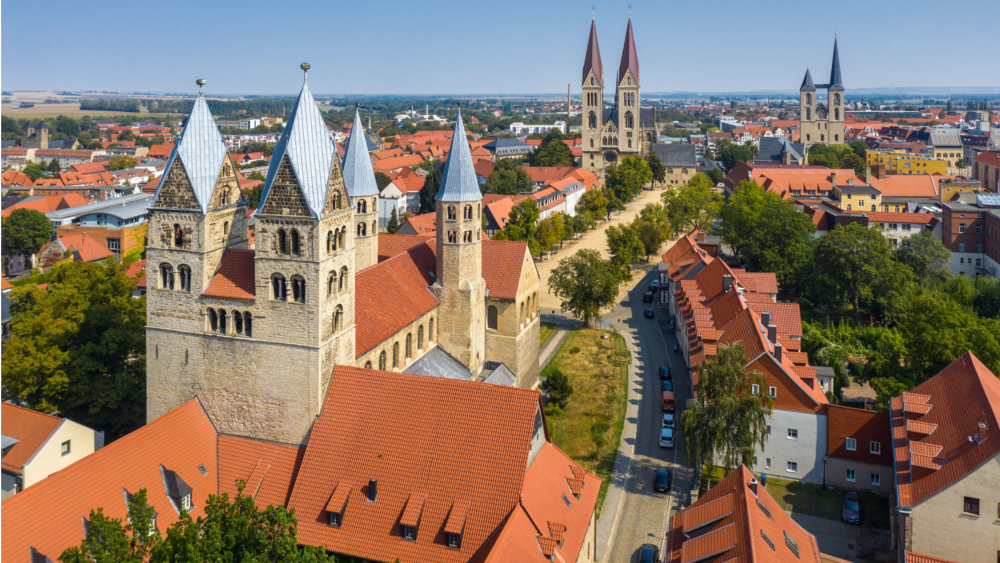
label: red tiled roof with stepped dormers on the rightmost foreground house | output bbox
[890,352,1000,507]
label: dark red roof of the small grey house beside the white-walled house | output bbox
[826,405,892,465]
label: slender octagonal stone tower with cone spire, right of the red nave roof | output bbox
[432,107,486,376]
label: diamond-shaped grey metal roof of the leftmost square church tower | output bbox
[156,91,227,213]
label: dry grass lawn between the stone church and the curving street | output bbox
[541,328,632,516]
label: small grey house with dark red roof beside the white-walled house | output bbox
[826,405,893,496]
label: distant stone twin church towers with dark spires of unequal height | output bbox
[799,39,845,150]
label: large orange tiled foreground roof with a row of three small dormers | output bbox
[282,366,548,563]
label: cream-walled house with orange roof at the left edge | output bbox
[0,404,104,500]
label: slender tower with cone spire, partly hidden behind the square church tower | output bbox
[344,104,379,272]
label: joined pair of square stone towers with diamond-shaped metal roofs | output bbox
[146,65,356,443]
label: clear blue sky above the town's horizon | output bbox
[0,0,1000,95]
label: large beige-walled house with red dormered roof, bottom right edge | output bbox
[889,352,1000,561]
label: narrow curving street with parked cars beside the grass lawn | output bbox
[598,271,694,563]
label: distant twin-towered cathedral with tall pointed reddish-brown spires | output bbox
[581,18,657,178]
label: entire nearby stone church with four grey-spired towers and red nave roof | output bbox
[146,68,540,444]
